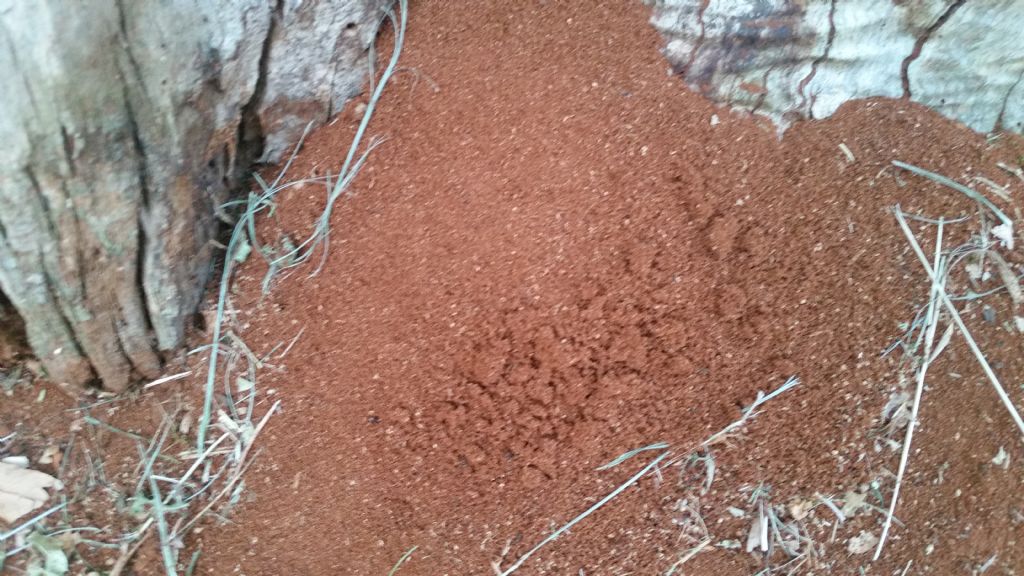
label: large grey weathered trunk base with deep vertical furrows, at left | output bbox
[0,0,384,390]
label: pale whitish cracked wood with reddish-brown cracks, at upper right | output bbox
[648,0,1024,133]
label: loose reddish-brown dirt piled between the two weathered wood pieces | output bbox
[2,0,1024,576]
